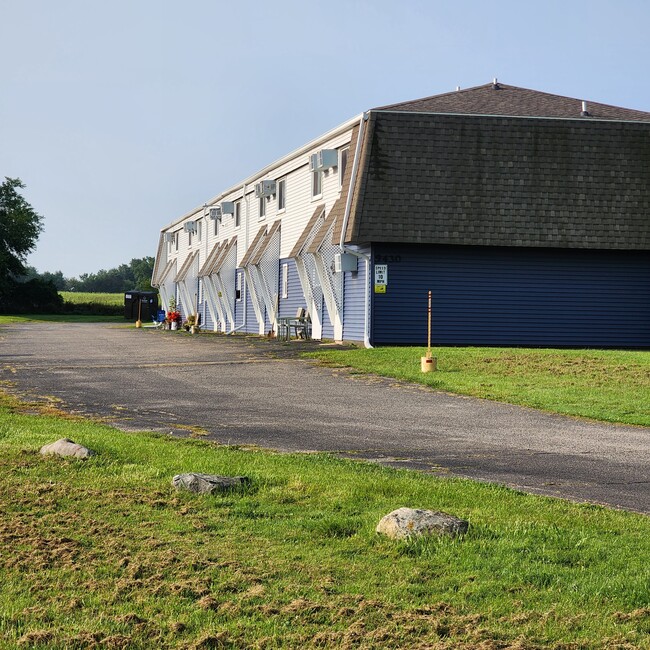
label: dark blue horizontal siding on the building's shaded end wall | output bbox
[372,245,650,347]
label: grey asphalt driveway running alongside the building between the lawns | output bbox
[0,323,650,513]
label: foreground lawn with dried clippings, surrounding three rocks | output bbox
[0,390,650,650]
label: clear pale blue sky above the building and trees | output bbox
[0,0,650,276]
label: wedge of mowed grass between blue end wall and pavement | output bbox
[307,347,650,426]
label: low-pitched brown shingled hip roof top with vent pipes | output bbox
[373,83,650,122]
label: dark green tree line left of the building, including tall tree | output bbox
[0,177,154,313]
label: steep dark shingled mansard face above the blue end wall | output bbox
[346,111,650,250]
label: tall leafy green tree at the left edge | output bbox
[0,176,43,296]
